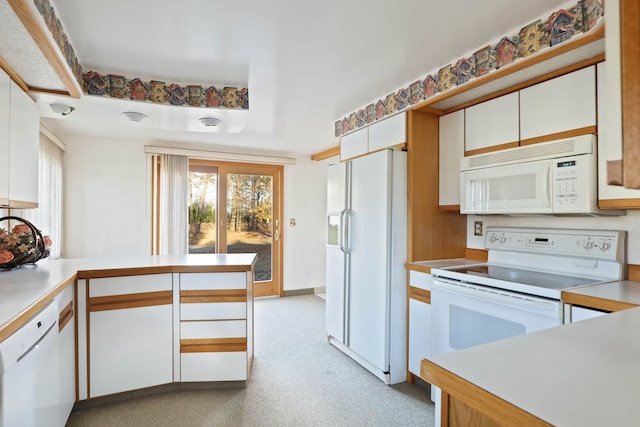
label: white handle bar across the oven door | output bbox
[431,278,557,311]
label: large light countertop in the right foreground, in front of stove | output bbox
[422,308,640,427]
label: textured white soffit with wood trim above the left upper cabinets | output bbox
[0,0,81,98]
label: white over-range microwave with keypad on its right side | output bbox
[460,135,625,215]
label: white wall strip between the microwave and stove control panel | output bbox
[467,210,640,264]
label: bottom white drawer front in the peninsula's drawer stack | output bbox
[180,352,247,382]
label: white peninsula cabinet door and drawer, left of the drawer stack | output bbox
[87,274,173,397]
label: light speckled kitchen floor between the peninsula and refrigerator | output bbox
[67,295,434,427]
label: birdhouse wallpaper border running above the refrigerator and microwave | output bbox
[335,0,604,137]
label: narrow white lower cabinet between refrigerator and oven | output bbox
[408,271,432,376]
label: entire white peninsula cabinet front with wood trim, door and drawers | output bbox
[76,271,253,402]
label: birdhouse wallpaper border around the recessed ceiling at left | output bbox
[33,0,249,110]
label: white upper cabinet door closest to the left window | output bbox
[9,81,40,208]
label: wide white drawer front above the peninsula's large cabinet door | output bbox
[88,274,173,297]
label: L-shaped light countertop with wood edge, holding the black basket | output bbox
[0,254,256,341]
